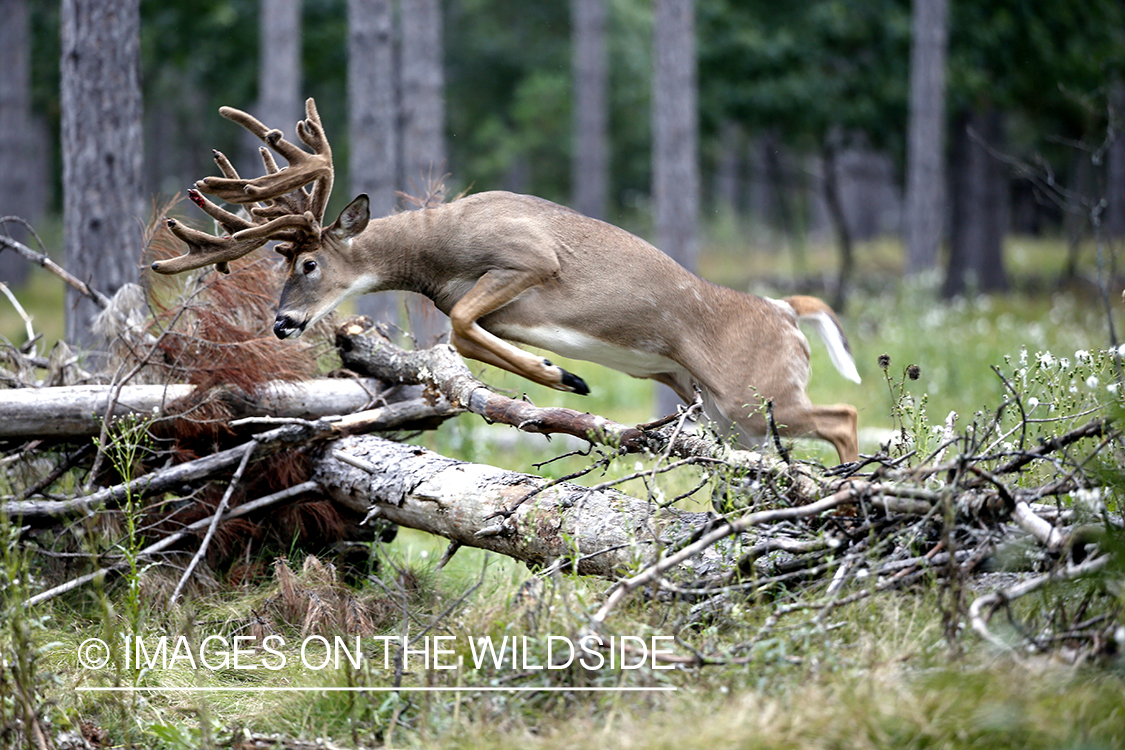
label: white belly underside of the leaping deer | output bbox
[493,324,683,378]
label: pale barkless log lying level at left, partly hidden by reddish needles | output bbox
[0,378,400,439]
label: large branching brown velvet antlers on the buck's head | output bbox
[152,99,334,274]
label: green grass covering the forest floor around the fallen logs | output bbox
[0,229,1125,749]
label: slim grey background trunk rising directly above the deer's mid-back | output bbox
[570,0,610,219]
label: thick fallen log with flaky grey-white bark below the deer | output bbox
[313,435,711,578]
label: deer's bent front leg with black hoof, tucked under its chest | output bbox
[449,270,590,396]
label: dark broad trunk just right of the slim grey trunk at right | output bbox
[942,108,1008,297]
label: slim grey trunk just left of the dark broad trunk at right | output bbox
[903,0,950,274]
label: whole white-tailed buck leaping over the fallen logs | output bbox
[153,99,860,461]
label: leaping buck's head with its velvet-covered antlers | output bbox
[152,99,370,338]
